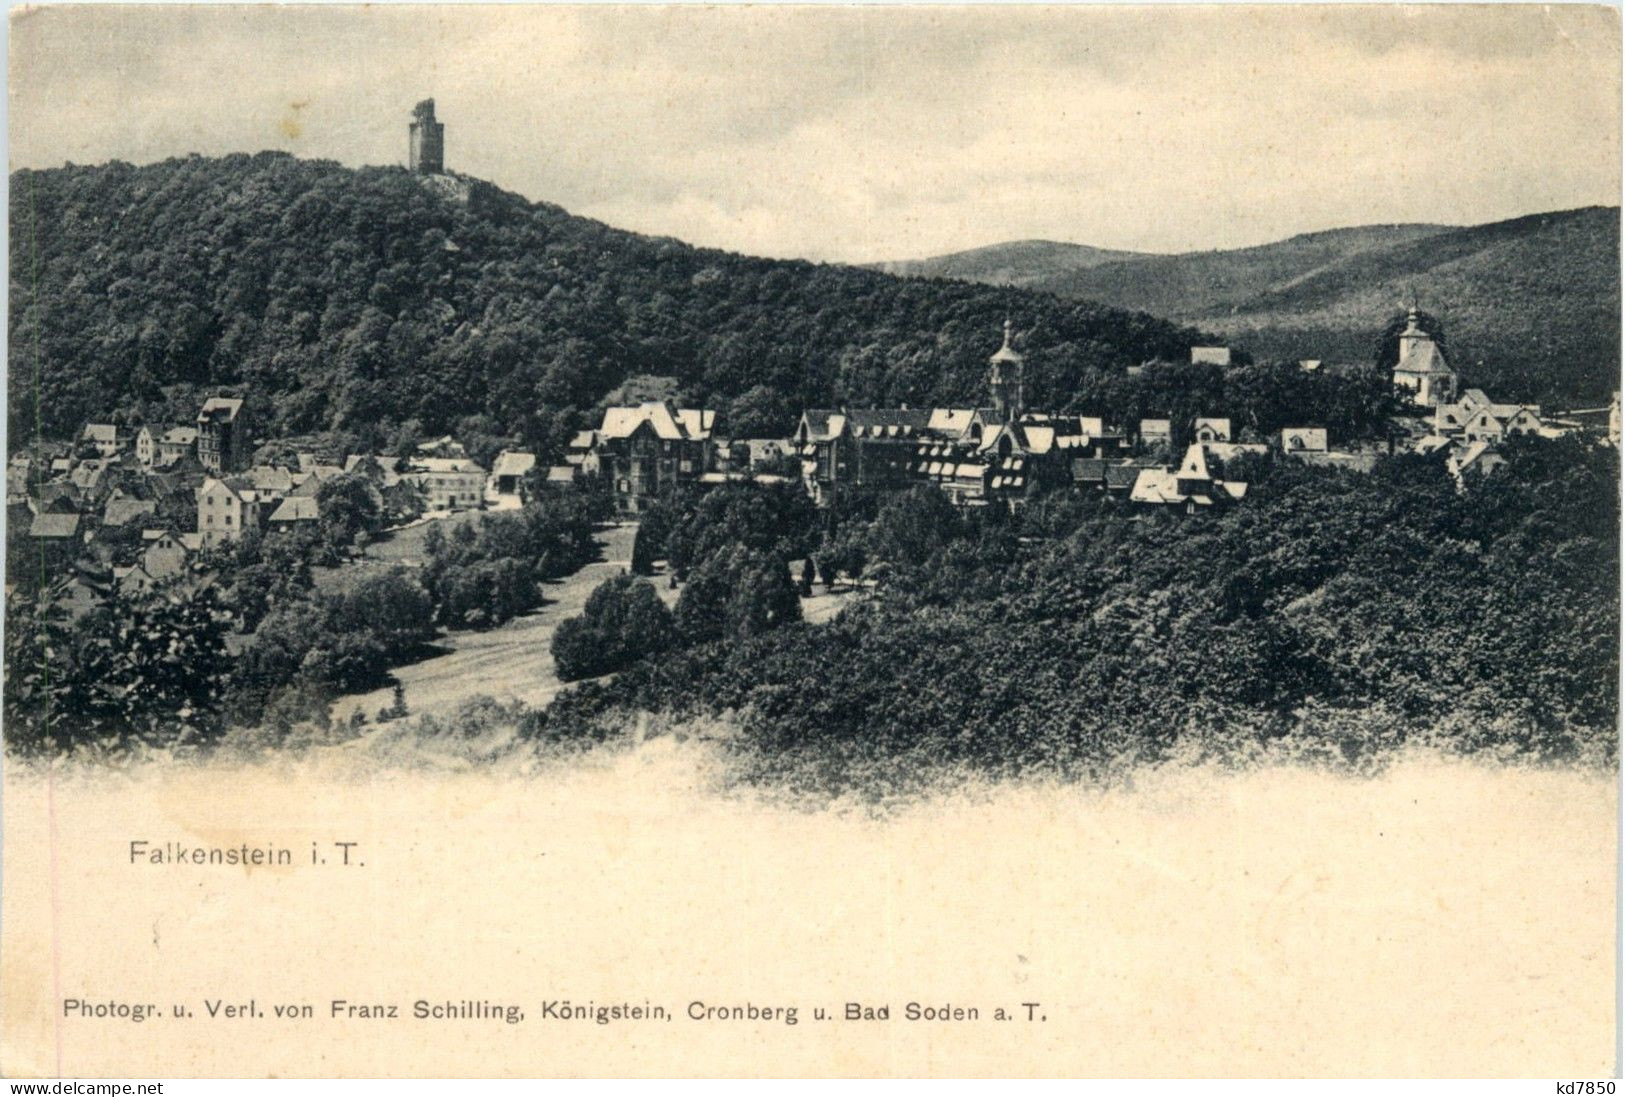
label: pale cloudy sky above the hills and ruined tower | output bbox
[10,3,1620,262]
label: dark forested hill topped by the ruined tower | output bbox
[8,153,1206,447]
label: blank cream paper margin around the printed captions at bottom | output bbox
[0,739,1617,1077]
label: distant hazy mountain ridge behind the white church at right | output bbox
[886,206,1620,403]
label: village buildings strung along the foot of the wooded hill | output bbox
[7,300,1619,630]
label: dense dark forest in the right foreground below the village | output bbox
[531,439,1619,790]
